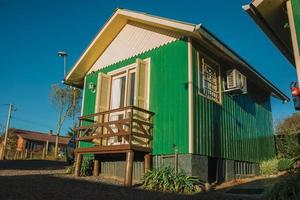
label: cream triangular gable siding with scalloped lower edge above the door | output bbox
[89,22,181,72]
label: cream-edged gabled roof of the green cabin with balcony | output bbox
[65,9,289,101]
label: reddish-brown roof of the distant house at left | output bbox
[15,129,71,145]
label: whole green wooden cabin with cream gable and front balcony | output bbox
[65,9,289,185]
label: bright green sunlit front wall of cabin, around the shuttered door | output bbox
[82,40,188,154]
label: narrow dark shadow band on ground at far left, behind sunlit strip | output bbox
[0,160,67,170]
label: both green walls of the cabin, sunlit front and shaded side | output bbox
[81,40,275,162]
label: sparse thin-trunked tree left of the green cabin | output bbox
[50,84,81,156]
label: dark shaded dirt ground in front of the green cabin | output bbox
[0,161,257,200]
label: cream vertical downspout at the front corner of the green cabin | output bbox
[188,37,194,154]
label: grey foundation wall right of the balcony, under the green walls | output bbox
[152,154,259,182]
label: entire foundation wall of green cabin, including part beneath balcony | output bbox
[96,154,259,183]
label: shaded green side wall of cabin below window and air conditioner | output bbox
[193,44,275,162]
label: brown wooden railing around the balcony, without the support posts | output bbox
[76,106,154,150]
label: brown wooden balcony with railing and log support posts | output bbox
[75,106,154,186]
